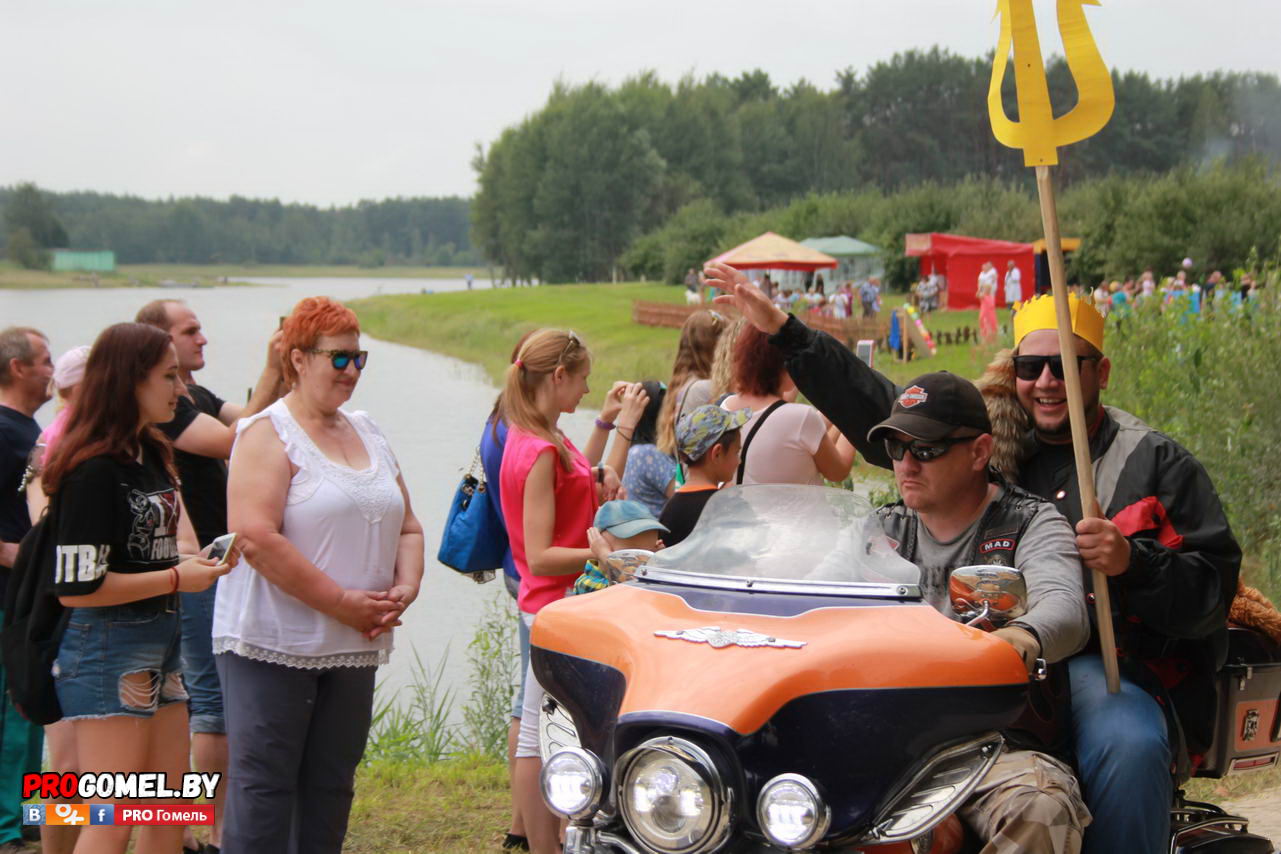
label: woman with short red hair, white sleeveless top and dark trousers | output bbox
[213,297,423,854]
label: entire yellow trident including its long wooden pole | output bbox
[988,0,1121,694]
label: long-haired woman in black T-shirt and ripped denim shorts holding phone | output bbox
[44,323,237,854]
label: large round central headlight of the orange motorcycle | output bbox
[619,737,731,854]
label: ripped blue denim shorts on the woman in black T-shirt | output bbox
[54,598,187,721]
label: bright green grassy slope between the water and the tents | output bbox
[351,283,991,406]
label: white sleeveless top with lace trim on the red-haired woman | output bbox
[214,399,405,668]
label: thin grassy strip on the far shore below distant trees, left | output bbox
[0,261,489,289]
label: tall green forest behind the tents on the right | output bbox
[471,47,1281,282]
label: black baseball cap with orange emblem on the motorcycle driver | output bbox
[867,371,991,442]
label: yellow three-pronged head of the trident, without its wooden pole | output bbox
[988,0,1116,166]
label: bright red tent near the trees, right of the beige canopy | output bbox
[904,233,1036,309]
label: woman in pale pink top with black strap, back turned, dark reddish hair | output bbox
[722,325,854,485]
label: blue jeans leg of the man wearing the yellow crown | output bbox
[1067,654,1173,854]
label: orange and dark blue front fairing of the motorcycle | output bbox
[530,581,1027,837]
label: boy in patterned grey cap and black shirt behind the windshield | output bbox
[658,403,752,545]
